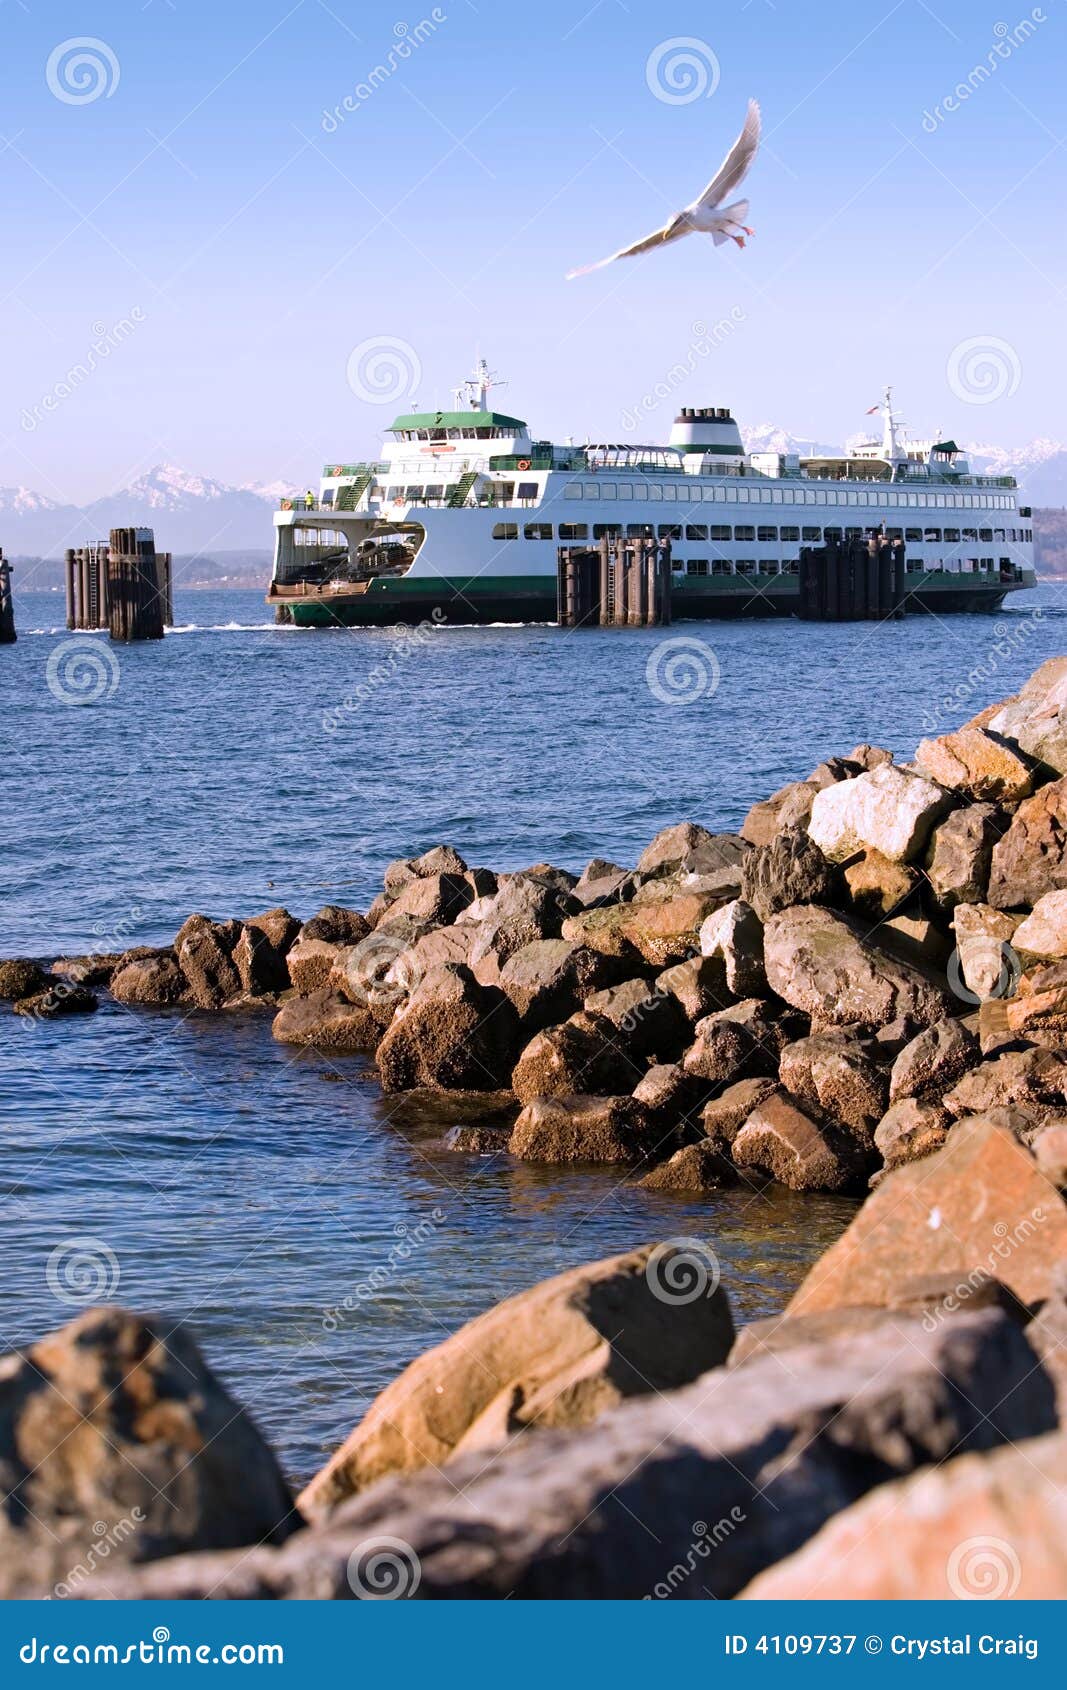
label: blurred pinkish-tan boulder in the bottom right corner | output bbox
[741,1431,1067,1602]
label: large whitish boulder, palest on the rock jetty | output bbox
[808,762,952,862]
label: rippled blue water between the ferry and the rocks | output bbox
[0,581,1067,1480]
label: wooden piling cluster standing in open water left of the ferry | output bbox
[66,527,174,641]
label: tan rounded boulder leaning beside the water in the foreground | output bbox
[299,1244,734,1516]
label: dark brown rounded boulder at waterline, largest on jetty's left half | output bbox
[377,963,519,1092]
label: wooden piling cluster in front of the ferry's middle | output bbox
[556,536,671,629]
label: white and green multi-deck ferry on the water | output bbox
[267,360,1035,627]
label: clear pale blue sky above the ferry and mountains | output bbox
[0,0,1067,502]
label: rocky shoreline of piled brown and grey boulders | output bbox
[0,657,1067,1599]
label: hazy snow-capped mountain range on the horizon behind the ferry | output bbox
[0,436,1067,559]
